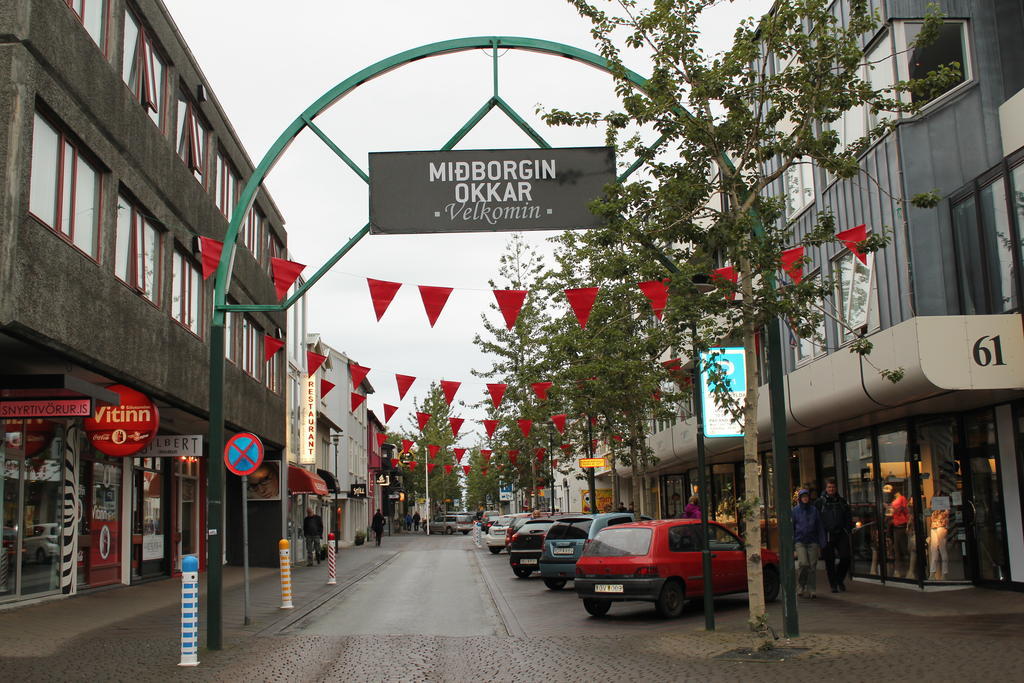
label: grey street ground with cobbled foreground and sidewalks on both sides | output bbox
[0,537,1024,682]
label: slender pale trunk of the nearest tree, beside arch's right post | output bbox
[738,259,770,649]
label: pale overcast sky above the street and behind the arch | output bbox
[164,0,771,445]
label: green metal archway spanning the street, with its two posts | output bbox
[207,36,798,649]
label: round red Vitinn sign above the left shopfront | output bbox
[83,384,160,457]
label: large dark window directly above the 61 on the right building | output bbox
[952,177,1018,315]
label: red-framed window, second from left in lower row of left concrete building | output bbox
[114,195,163,305]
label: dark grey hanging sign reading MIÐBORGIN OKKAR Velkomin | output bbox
[370,147,615,234]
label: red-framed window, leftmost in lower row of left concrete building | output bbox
[29,114,99,259]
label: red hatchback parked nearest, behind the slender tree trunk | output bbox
[575,519,779,617]
